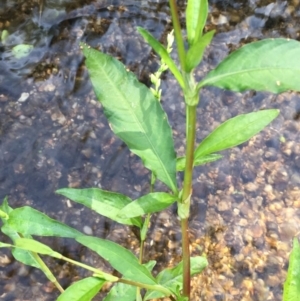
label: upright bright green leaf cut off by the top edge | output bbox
[185,0,208,45]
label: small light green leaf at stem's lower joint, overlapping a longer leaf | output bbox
[119,192,178,218]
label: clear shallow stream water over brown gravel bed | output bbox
[0,0,300,300]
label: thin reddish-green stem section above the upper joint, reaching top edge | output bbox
[169,0,185,71]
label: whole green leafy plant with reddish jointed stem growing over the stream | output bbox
[0,0,300,301]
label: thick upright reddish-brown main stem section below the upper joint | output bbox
[179,105,197,300]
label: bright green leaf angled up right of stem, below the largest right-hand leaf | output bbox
[195,109,279,160]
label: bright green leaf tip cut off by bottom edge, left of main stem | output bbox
[56,277,105,301]
